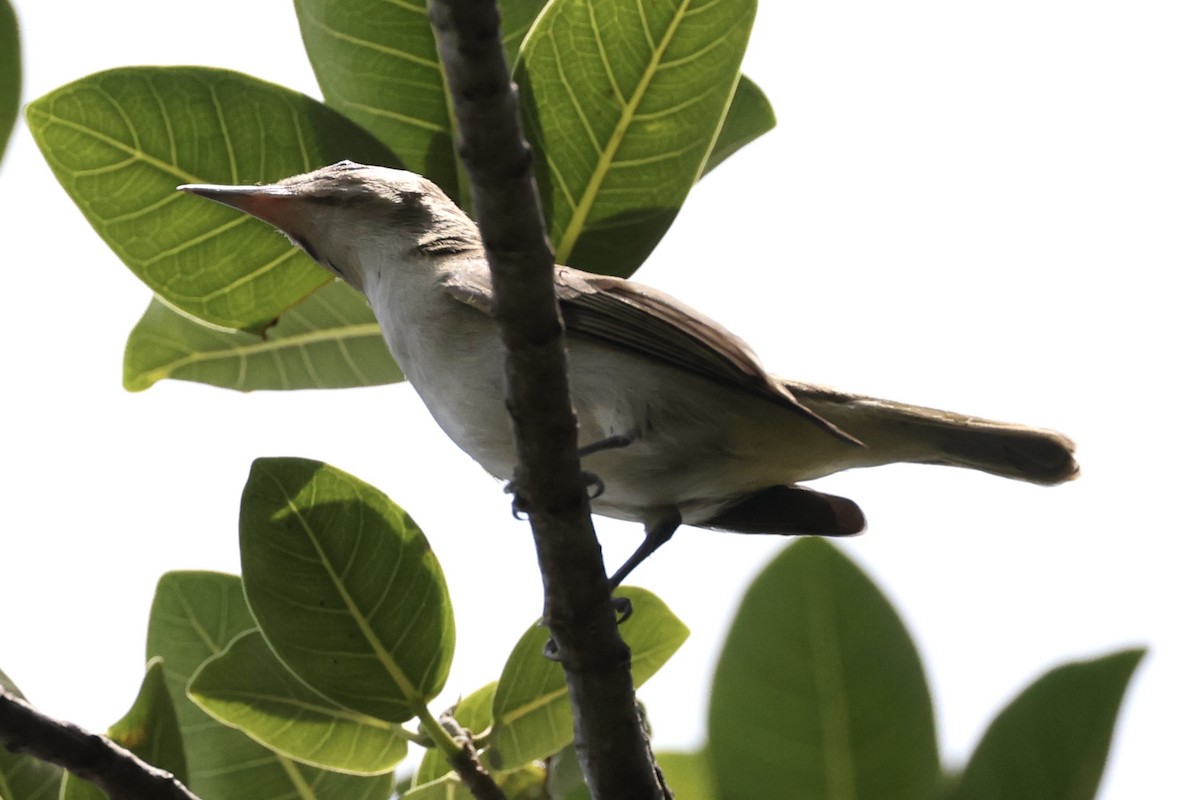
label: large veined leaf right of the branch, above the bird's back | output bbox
[516,0,755,275]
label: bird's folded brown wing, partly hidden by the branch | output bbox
[443,260,862,445]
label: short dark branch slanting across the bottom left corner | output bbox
[0,686,199,800]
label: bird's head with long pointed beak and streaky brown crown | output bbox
[179,161,481,291]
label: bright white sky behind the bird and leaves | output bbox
[0,0,1200,800]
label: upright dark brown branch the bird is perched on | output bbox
[428,0,670,800]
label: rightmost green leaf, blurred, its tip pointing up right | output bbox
[948,649,1145,800]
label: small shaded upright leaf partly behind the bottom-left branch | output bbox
[60,658,187,800]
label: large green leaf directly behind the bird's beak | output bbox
[26,67,396,331]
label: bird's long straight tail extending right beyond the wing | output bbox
[786,381,1079,486]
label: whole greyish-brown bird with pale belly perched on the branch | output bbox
[179,161,1079,587]
